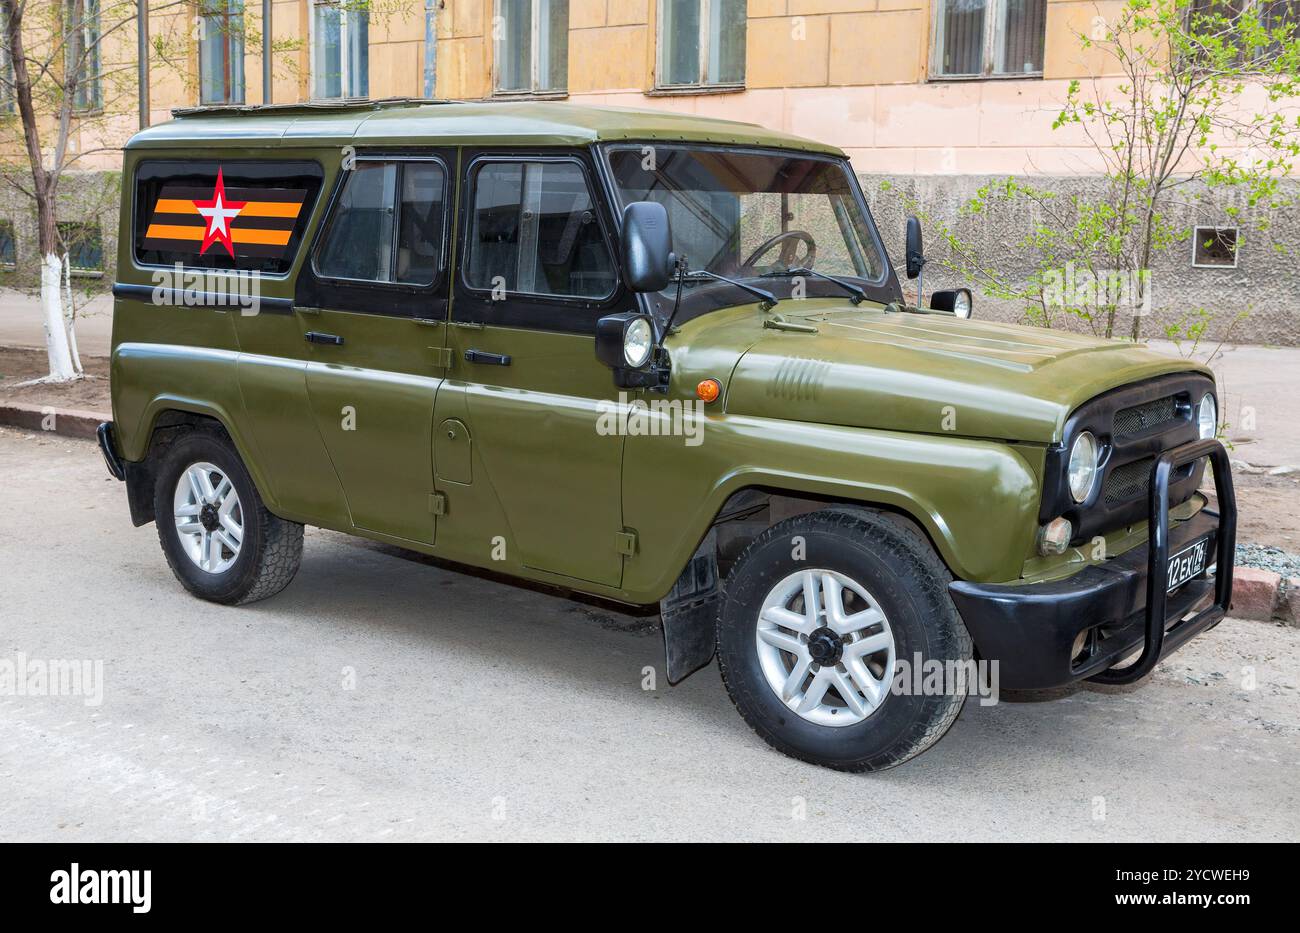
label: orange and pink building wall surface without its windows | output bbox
[0,0,1300,343]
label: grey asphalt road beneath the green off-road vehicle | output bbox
[0,429,1300,841]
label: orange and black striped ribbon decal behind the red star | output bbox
[144,185,307,259]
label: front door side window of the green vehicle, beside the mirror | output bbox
[465,161,616,299]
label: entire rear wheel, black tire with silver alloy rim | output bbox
[153,430,303,604]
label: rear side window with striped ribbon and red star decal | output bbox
[134,160,322,274]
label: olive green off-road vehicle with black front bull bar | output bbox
[100,101,1235,771]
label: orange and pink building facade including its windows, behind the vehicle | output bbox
[0,0,1300,339]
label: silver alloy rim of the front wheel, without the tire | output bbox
[755,569,894,726]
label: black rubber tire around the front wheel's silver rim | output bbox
[718,507,972,772]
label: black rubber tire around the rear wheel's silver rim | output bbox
[153,429,303,606]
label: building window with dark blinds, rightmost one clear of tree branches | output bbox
[930,0,1047,78]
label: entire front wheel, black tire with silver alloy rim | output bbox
[718,507,972,771]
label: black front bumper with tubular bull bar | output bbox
[950,441,1236,689]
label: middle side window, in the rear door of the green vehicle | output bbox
[316,161,446,286]
